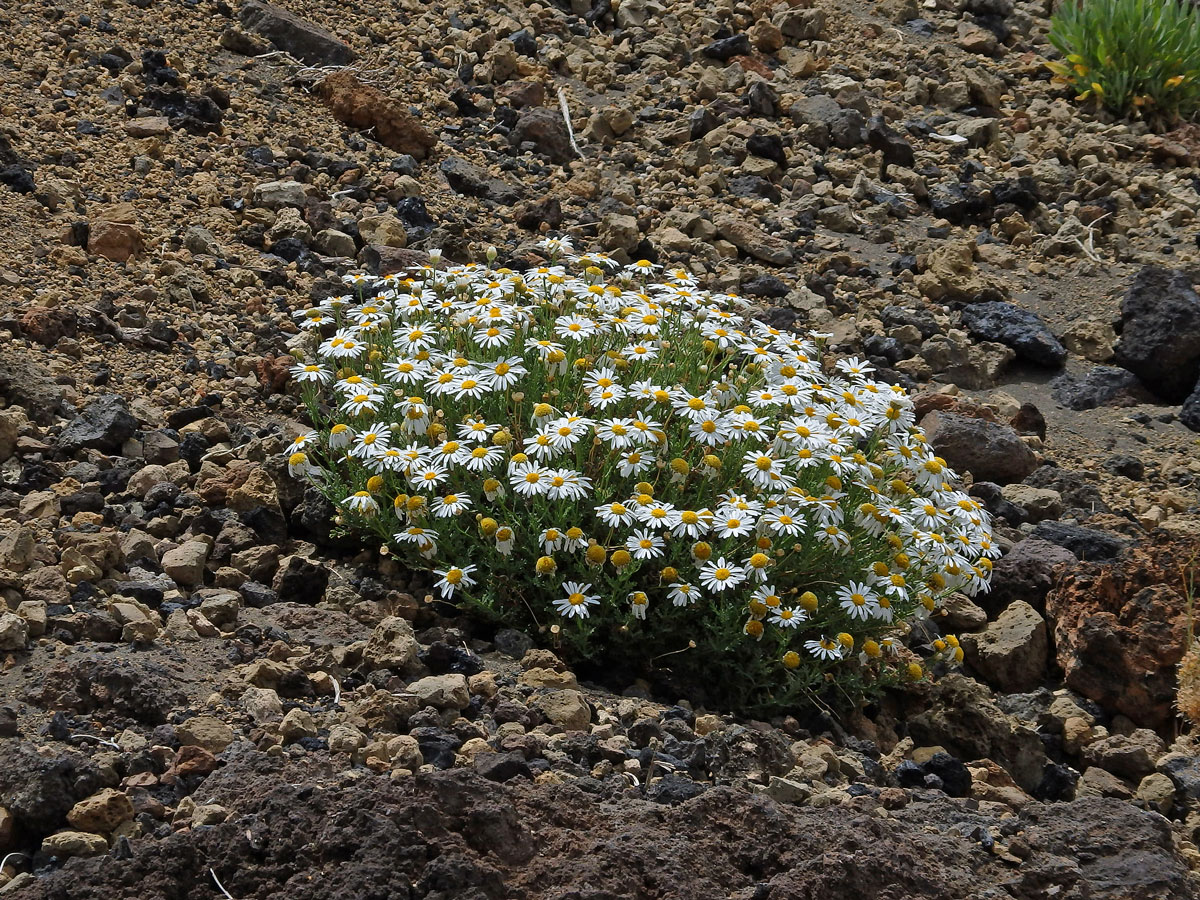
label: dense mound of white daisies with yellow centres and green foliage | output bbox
[289,239,997,712]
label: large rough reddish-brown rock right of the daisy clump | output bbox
[1046,546,1189,728]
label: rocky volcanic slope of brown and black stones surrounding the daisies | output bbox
[0,0,1200,900]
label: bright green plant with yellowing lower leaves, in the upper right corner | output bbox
[1048,0,1200,125]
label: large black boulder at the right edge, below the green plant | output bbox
[1114,265,1200,403]
